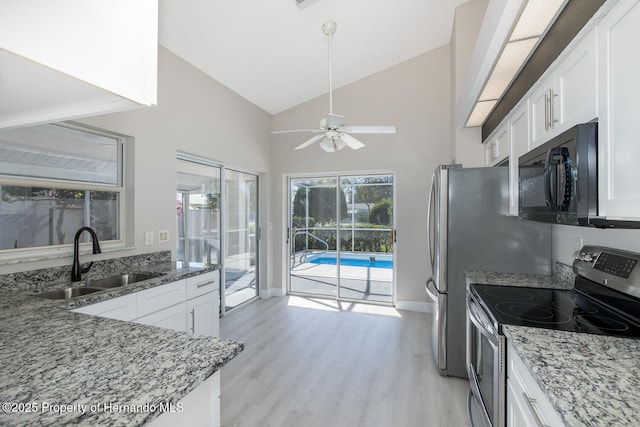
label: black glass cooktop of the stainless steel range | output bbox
[471,278,640,338]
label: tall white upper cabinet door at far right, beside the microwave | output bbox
[598,0,640,220]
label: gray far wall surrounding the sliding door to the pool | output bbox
[270,45,451,303]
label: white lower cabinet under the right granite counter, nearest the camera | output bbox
[507,345,564,427]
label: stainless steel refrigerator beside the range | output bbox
[426,165,551,378]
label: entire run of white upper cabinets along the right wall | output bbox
[484,0,640,221]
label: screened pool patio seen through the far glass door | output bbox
[288,174,394,304]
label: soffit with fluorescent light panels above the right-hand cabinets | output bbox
[456,0,617,134]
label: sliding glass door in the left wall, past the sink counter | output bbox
[176,156,259,315]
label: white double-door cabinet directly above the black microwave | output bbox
[529,31,598,148]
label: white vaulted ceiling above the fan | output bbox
[159,0,467,114]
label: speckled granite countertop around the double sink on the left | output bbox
[0,262,244,426]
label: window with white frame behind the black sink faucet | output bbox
[0,123,125,254]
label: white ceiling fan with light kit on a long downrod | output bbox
[271,21,396,153]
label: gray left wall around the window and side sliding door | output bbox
[2,47,272,284]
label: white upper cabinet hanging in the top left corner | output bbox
[0,0,158,128]
